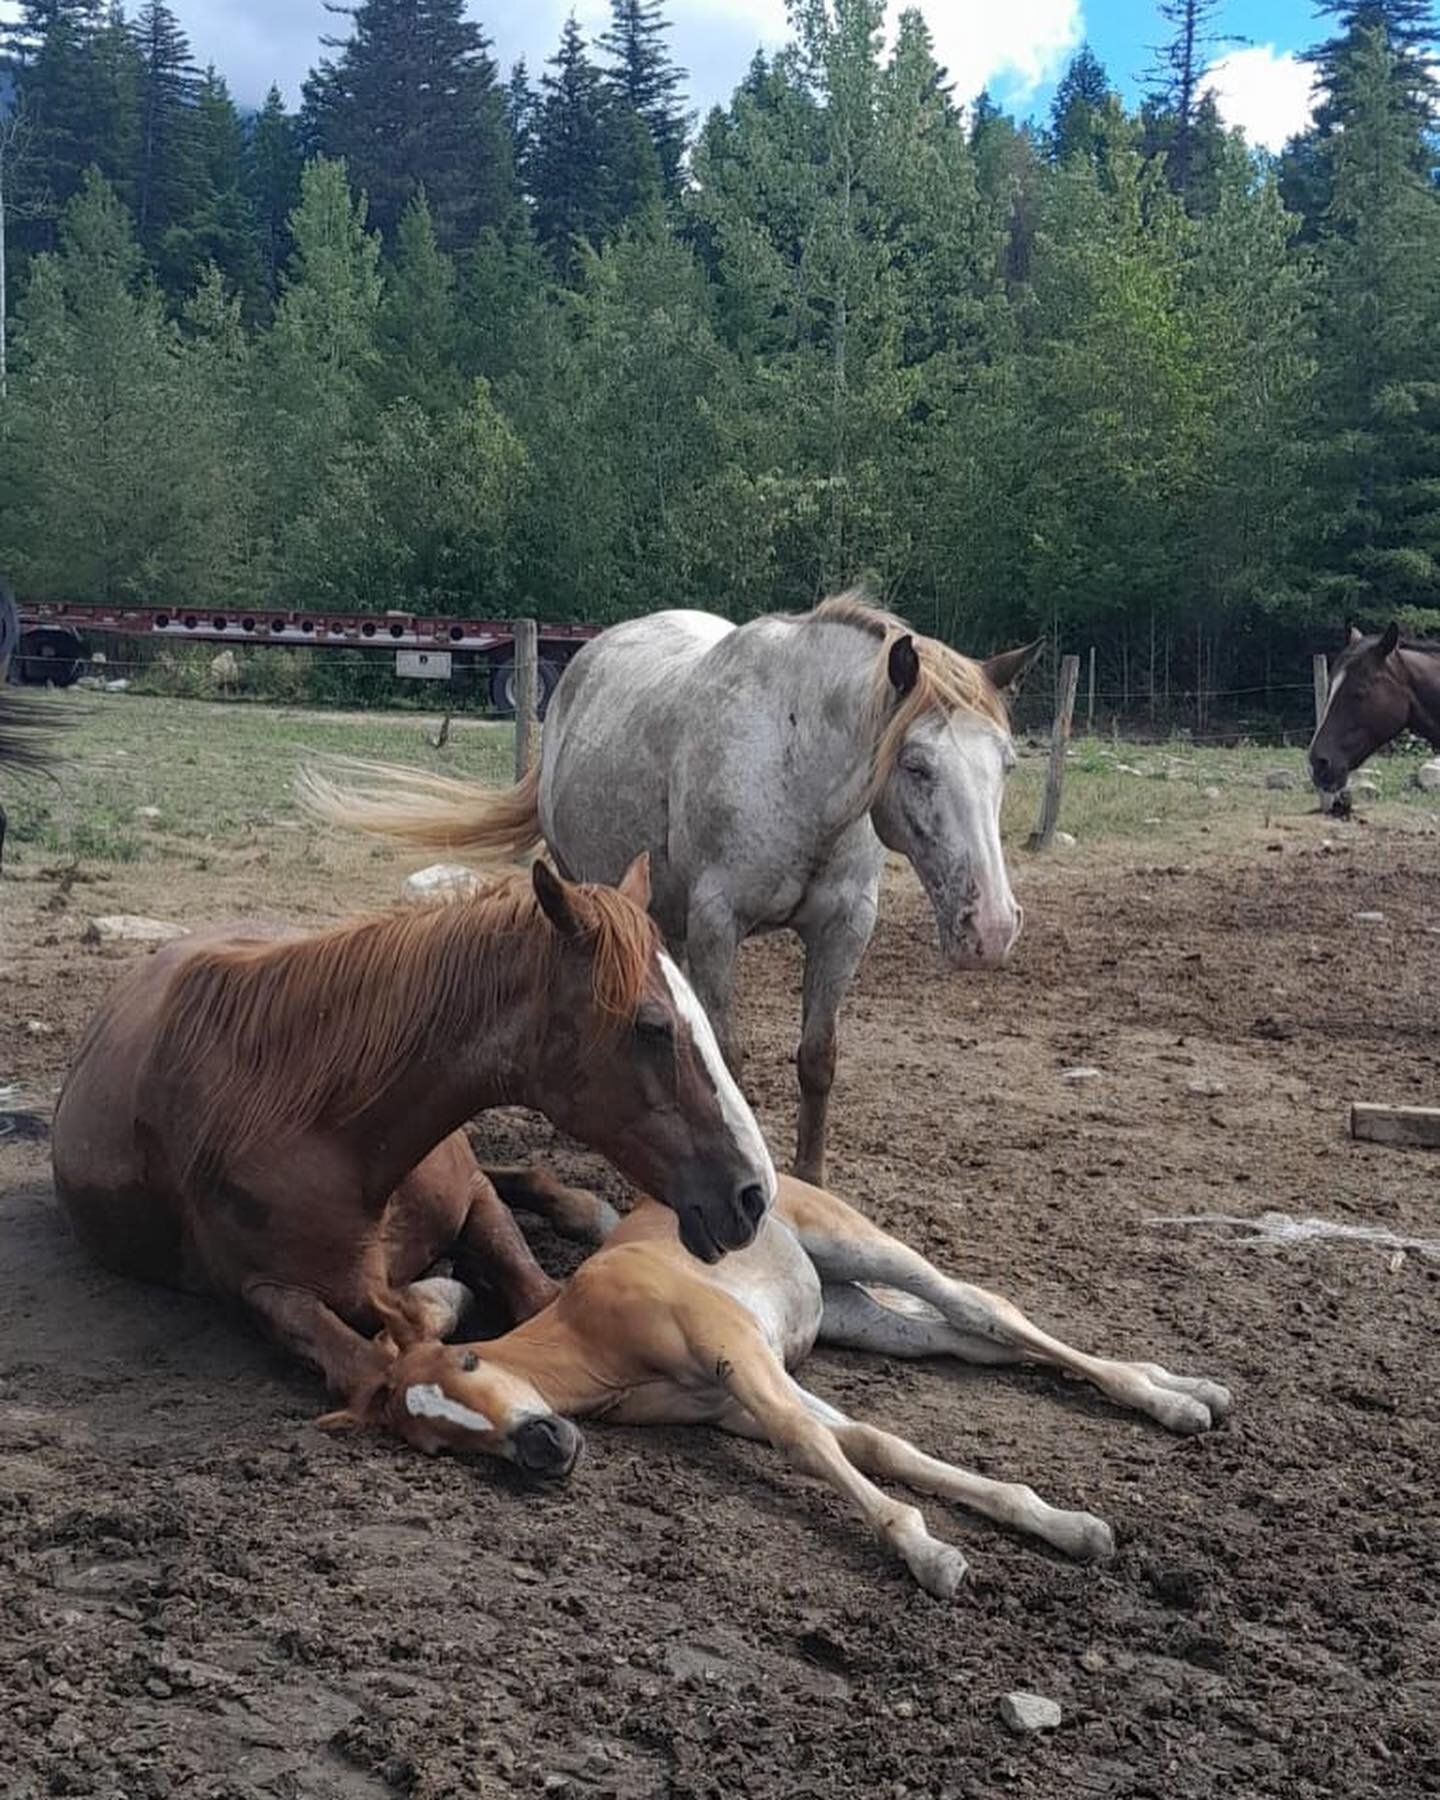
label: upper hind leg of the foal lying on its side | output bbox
[781,1190,1229,1431]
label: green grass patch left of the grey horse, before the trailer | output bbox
[0,693,515,862]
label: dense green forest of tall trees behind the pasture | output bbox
[0,0,1440,706]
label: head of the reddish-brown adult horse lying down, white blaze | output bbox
[533,857,776,1262]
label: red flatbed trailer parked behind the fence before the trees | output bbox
[14,599,601,711]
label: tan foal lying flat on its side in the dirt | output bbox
[334,1172,1229,1598]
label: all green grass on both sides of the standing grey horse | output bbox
[0,693,1440,862]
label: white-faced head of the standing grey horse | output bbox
[871,635,1042,968]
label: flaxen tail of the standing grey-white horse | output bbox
[297,760,542,860]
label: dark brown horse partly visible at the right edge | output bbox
[1310,625,1440,794]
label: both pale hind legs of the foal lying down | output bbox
[783,1190,1229,1431]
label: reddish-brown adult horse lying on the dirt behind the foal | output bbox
[52,859,776,1393]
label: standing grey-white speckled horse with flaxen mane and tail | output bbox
[304,594,1040,1181]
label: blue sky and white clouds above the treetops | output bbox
[0,0,1319,146]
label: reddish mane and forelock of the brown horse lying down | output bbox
[153,875,657,1183]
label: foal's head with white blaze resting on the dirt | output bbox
[319,1305,585,1481]
